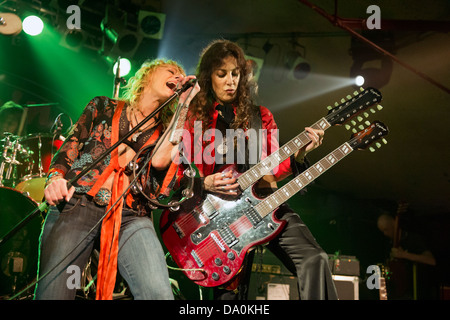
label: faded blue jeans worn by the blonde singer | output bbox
[35,196,173,300]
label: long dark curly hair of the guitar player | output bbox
[191,40,256,130]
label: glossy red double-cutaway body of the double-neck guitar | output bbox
[160,167,284,287]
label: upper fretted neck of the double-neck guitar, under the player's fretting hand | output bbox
[238,118,331,190]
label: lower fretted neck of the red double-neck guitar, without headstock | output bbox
[255,142,353,218]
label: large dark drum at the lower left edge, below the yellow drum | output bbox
[0,187,43,299]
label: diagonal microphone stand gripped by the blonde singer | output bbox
[0,82,193,247]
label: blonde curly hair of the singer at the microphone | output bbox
[121,59,186,127]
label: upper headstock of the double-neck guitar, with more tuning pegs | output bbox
[325,88,383,125]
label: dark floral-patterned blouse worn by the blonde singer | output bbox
[47,96,175,213]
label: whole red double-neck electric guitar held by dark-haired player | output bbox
[160,88,387,287]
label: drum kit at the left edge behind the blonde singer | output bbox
[0,133,62,299]
